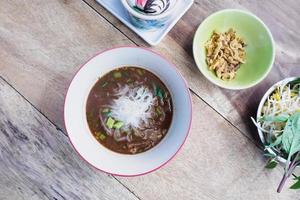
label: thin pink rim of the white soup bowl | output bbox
[64,46,192,177]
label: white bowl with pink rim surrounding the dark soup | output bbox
[64,47,192,176]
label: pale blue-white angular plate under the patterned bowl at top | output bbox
[96,0,194,46]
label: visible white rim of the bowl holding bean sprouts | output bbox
[256,77,296,163]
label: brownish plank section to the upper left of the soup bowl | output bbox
[0,0,131,131]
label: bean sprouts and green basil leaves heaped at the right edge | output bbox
[252,78,300,192]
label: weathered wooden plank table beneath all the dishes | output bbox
[0,0,300,200]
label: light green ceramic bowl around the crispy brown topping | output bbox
[193,9,275,89]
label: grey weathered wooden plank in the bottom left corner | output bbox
[0,78,138,200]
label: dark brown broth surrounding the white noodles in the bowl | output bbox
[86,67,173,154]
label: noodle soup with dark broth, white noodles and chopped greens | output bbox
[86,67,173,154]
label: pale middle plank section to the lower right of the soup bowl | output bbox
[119,96,300,200]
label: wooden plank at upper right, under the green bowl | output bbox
[84,0,300,139]
